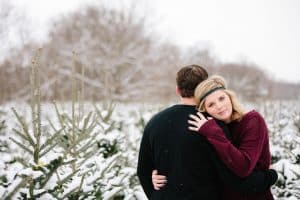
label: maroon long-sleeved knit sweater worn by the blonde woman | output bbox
[199,111,273,200]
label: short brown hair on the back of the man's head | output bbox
[176,65,208,97]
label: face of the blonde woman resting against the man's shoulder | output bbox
[204,90,232,123]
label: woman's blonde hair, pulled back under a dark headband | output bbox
[195,75,245,121]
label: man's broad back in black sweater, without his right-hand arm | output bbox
[138,105,220,200]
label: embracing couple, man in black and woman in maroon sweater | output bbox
[137,65,277,200]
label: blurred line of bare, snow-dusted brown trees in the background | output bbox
[0,1,300,102]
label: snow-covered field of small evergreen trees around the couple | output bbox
[0,101,300,200]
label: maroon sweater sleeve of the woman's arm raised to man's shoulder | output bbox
[199,115,267,177]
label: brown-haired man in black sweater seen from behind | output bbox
[137,65,277,200]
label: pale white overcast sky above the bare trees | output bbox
[7,0,300,83]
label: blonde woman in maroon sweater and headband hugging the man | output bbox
[152,76,274,200]
